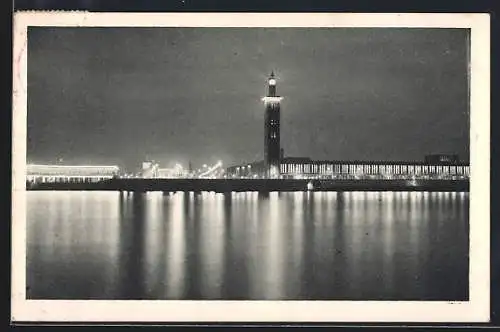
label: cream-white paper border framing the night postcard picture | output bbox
[11,12,490,323]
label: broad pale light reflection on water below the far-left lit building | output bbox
[27,192,121,299]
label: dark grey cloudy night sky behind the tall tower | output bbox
[28,27,469,168]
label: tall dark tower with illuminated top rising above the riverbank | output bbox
[262,72,282,178]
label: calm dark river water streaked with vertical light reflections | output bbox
[27,192,469,300]
